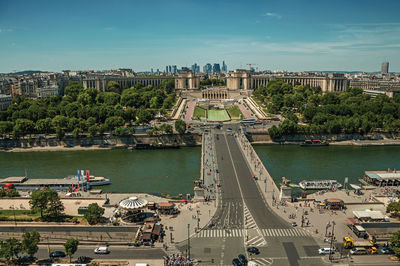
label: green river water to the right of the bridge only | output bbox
[254,145,400,184]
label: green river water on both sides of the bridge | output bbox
[0,145,400,195]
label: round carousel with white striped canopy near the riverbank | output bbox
[119,197,147,223]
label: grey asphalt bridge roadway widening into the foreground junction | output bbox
[182,130,324,266]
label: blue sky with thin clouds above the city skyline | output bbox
[0,0,400,72]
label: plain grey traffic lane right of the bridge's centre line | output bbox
[227,135,290,228]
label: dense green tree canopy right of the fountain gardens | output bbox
[254,80,400,138]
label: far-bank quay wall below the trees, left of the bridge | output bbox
[0,133,202,149]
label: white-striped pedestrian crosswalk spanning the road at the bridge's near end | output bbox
[194,228,310,238]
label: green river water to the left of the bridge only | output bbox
[0,147,201,195]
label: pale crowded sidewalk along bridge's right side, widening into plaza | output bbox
[237,134,396,258]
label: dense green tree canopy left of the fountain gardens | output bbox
[0,79,175,139]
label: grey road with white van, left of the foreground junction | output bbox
[36,245,166,259]
